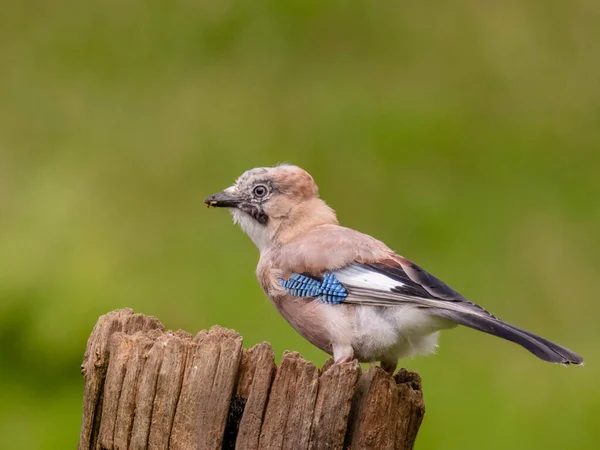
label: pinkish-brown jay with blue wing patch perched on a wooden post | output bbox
[205,164,583,374]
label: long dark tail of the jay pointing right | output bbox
[435,309,583,365]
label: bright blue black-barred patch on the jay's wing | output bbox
[279,272,348,305]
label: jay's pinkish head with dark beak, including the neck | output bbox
[204,165,337,250]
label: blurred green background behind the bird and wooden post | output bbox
[0,0,600,450]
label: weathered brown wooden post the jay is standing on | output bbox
[79,309,425,450]
